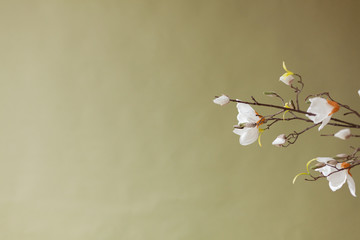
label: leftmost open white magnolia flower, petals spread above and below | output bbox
[233,103,263,146]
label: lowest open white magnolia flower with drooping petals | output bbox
[315,157,356,197]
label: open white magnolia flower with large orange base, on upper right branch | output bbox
[306,97,340,131]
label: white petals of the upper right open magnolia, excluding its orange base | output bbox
[306,97,333,123]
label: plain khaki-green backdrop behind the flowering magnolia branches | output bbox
[0,0,360,240]
